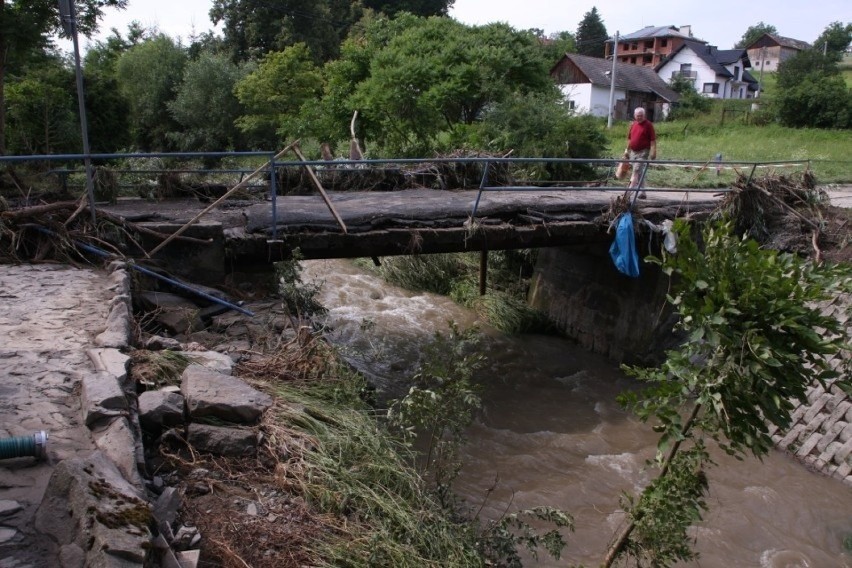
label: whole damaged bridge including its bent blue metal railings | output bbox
[0,151,805,283]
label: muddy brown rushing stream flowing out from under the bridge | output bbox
[303,261,852,568]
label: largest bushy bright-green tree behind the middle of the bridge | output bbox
[310,16,555,155]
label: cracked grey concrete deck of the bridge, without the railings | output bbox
[104,188,718,272]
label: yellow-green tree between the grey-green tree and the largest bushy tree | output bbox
[236,43,322,150]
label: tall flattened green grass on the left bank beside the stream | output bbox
[274,386,483,568]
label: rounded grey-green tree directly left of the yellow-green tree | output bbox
[168,51,245,152]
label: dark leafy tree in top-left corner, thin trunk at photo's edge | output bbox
[0,0,127,155]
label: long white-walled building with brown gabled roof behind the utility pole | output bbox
[550,53,679,120]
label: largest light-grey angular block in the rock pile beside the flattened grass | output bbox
[180,365,272,424]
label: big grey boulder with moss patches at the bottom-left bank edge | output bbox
[36,452,152,568]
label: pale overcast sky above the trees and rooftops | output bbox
[82,0,852,49]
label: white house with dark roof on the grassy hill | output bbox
[656,40,758,99]
